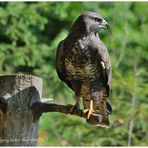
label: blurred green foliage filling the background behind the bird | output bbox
[0,2,148,146]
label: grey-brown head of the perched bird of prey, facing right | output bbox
[73,12,108,34]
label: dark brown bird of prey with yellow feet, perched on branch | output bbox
[56,12,112,126]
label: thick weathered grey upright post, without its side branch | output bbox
[0,75,42,146]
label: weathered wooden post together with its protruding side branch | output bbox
[0,75,109,146]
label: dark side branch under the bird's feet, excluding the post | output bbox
[31,102,109,127]
